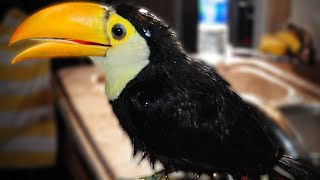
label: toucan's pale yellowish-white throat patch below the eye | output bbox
[91,33,150,101]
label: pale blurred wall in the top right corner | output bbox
[290,0,320,60]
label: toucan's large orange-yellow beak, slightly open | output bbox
[9,3,110,63]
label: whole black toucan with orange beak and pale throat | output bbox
[9,2,319,179]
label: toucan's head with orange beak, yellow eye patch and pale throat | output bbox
[9,3,180,100]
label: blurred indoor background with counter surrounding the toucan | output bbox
[0,0,320,179]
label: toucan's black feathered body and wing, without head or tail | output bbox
[113,62,277,174]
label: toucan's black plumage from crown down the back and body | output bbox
[110,5,318,177]
